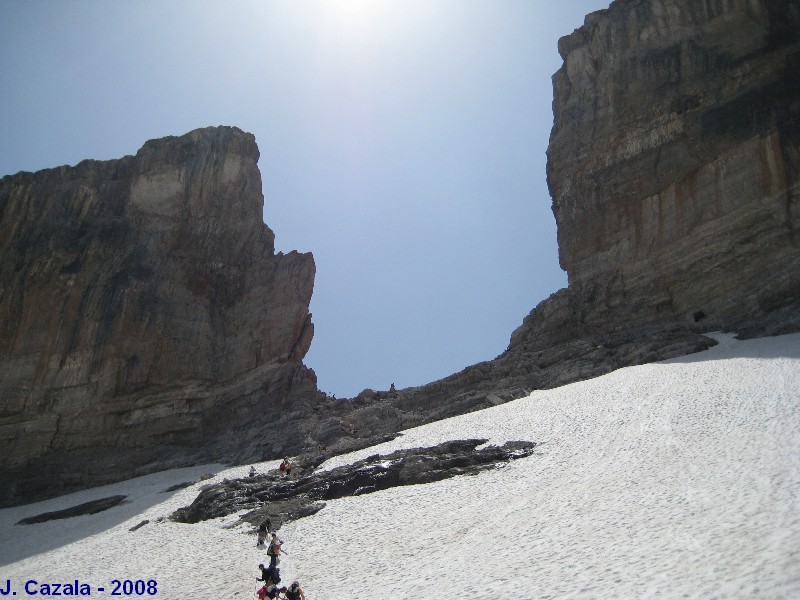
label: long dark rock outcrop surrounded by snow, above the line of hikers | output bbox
[172,440,536,529]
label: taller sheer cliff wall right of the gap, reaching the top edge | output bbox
[512,0,800,345]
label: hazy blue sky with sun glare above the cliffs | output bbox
[0,0,609,397]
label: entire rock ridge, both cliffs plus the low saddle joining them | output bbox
[0,0,800,502]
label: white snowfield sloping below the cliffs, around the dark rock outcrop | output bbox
[0,334,800,600]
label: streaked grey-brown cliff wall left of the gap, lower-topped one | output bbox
[0,127,316,502]
